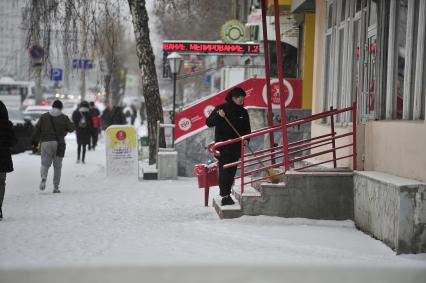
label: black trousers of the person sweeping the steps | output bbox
[217,151,240,197]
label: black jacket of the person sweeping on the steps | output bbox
[206,94,251,156]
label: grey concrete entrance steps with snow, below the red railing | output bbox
[213,171,354,220]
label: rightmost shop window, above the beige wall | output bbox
[386,0,426,120]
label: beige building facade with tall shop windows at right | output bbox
[312,0,426,182]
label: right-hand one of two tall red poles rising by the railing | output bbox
[274,0,290,171]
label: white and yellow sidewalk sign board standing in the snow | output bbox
[105,125,138,176]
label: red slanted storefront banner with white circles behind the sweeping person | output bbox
[175,79,302,143]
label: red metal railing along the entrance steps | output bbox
[208,102,357,193]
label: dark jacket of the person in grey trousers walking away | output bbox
[32,108,74,142]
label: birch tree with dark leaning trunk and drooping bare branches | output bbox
[26,0,165,164]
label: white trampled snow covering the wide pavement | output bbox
[0,135,426,274]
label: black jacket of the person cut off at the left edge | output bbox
[0,101,18,173]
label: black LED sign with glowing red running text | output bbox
[163,40,260,55]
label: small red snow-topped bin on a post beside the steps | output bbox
[194,162,219,206]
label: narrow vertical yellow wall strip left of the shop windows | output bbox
[302,14,315,109]
